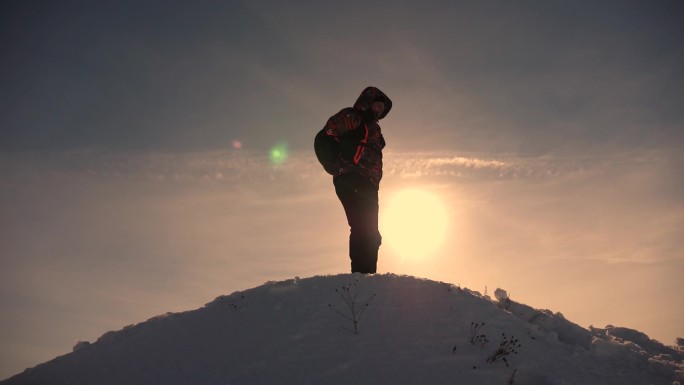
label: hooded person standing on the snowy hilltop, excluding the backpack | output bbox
[324,87,392,274]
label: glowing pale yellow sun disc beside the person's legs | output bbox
[380,189,447,259]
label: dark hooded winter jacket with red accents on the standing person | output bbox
[325,87,392,186]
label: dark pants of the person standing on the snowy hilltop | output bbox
[334,173,382,274]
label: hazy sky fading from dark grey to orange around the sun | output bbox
[0,1,684,378]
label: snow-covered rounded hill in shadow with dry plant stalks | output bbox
[0,274,684,385]
